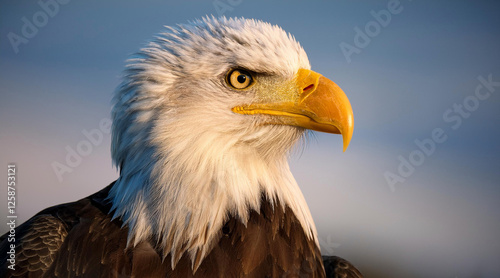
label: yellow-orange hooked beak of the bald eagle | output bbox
[232,69,354,151]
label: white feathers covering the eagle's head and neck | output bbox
[110,18,317,267]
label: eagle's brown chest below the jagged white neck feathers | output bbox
[131,197,325,277]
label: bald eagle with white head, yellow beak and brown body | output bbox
[0,17,361,277]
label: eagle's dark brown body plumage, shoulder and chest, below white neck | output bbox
[0,181,361,277]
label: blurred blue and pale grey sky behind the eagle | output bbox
[0,0,500,278]
